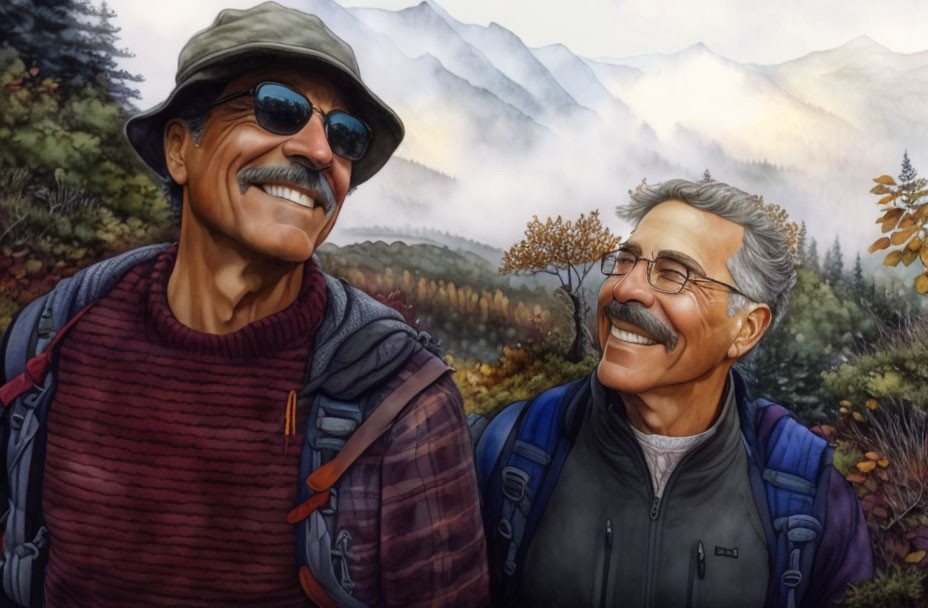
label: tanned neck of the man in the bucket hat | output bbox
[167,210,305,335]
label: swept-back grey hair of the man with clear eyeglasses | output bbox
[616,179,796,329]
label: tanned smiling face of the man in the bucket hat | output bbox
[165,70,351,262]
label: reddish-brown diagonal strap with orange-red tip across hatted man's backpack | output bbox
[287,357,450,608]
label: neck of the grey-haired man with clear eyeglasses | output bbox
[619,363,731,437]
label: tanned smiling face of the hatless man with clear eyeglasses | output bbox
[597,200,769,395]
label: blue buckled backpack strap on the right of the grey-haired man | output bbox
[736,370,832,608]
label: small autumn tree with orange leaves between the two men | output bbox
[499,211,621,361]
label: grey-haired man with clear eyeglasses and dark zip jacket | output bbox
[477,180,872,608]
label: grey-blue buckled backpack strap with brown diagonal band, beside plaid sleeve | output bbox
[287,357,450,608]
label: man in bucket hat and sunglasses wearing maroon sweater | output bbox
[0,2,488,607]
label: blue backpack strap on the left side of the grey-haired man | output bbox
[477,376,590,603]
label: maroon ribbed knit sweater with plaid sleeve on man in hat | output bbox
[42,248,489,608]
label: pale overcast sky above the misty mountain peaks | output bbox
[109,0,928,108]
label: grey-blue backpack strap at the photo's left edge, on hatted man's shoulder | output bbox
[2,245,166,606]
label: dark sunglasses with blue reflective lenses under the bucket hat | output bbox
[209,82,372,161]
